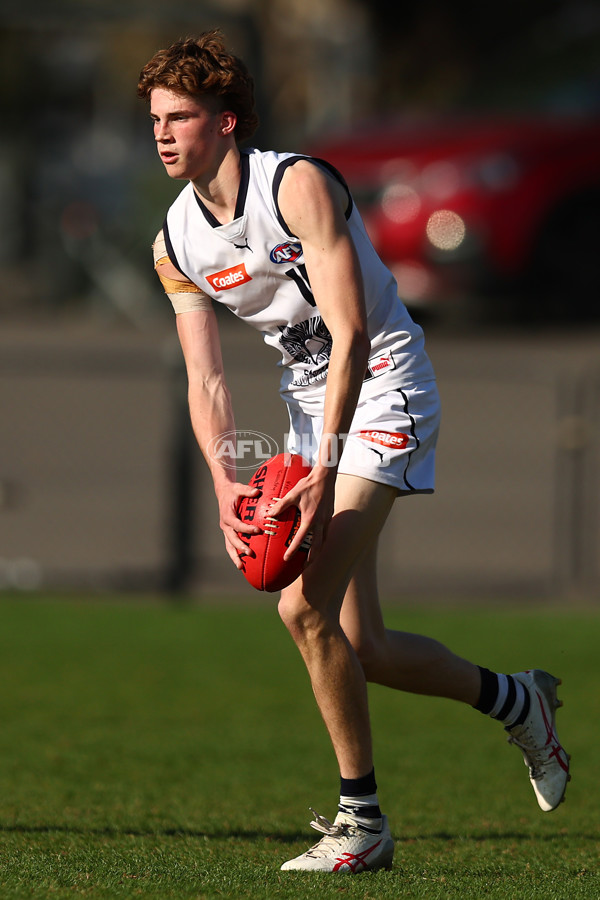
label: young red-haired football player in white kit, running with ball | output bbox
[138,31,569,873]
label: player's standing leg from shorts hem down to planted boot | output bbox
[280,478,394,873]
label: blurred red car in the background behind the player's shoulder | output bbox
[309,117,600,319]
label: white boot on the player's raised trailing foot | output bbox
[506,669,571,812]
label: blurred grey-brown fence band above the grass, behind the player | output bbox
[0,316,600,600]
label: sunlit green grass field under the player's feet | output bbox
[0,595,600,900]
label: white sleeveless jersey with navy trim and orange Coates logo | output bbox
[163,150,434,413]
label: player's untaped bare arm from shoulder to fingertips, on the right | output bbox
[273,161,370,557]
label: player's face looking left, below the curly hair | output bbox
[150,88,226,181]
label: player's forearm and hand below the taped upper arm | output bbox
[177,309,260,569]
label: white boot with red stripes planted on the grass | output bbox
[281,808,394,875]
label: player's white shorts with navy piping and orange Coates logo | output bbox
[288,381,440,494]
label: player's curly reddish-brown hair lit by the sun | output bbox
[138,30,258,142]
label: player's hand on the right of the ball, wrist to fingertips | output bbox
[270,465,335,563]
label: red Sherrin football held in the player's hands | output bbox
[238,453,311,591]
